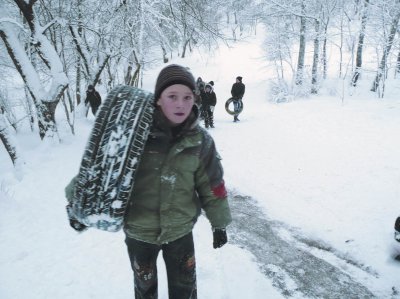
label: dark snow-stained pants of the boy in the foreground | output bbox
[125,233,197,299]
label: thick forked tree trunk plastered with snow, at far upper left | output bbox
[0,0,68,139]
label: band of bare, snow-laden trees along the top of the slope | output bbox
[0,0,400,159]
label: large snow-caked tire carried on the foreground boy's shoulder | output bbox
[72,85,154,232]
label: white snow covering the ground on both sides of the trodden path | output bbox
[0,27,400,299]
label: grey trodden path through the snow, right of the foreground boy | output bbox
[229,194,377,298]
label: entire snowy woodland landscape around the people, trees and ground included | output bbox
[0,0,400,299]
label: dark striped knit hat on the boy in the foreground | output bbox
[154,64,196,101]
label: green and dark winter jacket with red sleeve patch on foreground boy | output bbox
[124,109,232,244]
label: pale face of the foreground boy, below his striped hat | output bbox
[157,84,194,125]
